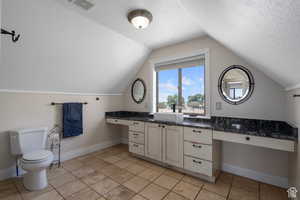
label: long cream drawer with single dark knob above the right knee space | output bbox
[213,131,295,152]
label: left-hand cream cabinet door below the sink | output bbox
[145,123,162,161]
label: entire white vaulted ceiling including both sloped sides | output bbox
[0,0,300,93]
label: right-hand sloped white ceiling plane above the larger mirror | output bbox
[181,0,300,88]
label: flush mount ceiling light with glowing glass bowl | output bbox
[127,9,152,29]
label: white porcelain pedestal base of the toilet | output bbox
[23,169,48,190]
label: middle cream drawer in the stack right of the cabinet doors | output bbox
[184,141,212,161]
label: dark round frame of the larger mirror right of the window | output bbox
[218,65,255,105]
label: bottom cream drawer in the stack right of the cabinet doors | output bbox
[184,156,213,176]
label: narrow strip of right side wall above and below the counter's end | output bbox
[287,89,300,195]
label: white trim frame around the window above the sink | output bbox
[150,49,211,119]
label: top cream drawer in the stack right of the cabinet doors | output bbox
[184,127,212,144]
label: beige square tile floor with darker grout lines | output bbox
[0,145,287,200]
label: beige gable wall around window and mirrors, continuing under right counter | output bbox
[123,37,288,184]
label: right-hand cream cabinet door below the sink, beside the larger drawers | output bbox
[163,126,183,168]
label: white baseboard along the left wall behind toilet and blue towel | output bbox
[0,139,121,180]
